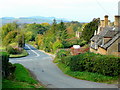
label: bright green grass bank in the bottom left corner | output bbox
[2,64,43,88]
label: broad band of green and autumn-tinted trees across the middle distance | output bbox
[0,19,99,53]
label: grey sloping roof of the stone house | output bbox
[91,27,120,49]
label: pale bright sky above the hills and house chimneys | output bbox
[0,0,120,22]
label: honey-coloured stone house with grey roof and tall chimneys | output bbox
[90,15,120,57]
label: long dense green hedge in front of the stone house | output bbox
[61,52,120,76]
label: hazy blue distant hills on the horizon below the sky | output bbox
[0,16,69,25]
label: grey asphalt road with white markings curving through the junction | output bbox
[10,45,117,88]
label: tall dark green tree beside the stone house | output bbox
[82,19,100,42]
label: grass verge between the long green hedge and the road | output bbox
[57,62,118,84]
